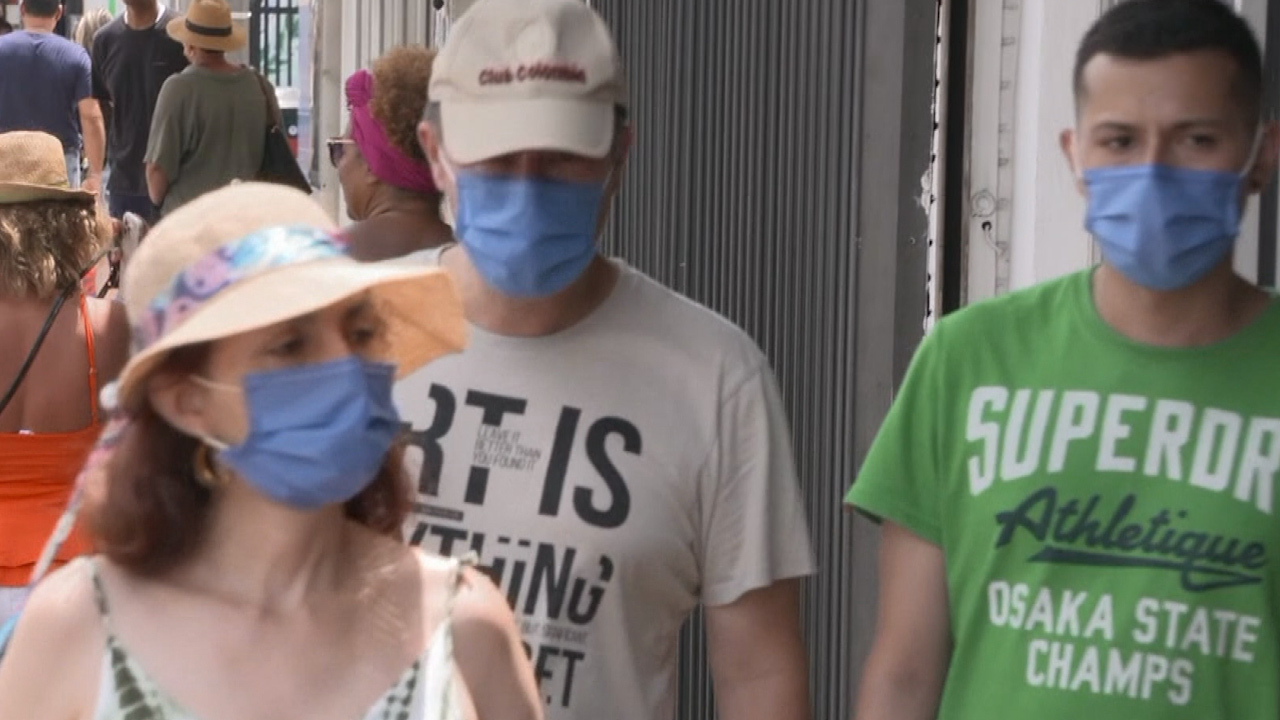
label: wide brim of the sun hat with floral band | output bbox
[116,258,468,409]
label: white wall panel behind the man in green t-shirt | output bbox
[965,0,1266,302]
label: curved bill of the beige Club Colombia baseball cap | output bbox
[440,97,614,164]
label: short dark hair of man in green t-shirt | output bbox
[1074,0,1262,117]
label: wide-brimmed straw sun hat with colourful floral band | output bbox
[106,183,467,410]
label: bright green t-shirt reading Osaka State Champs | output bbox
[847,272,1280,720]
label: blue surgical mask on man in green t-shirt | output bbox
[1084,133,1262,291]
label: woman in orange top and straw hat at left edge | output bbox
[0,132,129,624]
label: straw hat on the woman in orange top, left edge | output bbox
[0,131,93,205]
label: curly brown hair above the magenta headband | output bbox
[369,45,435,163]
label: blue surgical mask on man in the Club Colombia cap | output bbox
[454,163,608,297]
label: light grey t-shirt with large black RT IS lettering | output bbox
[396,251,814,720]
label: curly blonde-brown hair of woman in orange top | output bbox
[0,199,110,300]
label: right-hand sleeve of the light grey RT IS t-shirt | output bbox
[700,357,814,607]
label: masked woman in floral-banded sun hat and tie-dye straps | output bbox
[0,183,541,720]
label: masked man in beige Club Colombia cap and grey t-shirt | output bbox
[396,0,814,720]
